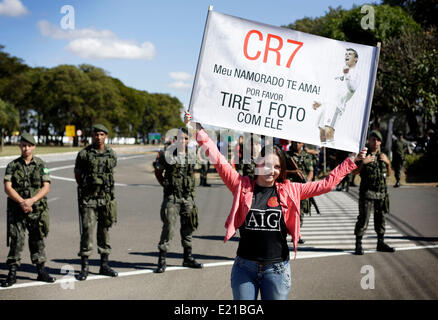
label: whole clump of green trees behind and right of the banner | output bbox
[289,1,438,133]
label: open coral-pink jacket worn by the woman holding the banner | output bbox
[196,130,356,255]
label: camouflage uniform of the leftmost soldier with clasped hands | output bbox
[4,157,50,266]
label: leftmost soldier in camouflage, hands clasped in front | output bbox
[2,133,55,287]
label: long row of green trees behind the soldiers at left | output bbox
[0,46,183,144]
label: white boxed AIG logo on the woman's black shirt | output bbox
[246,208,281,231]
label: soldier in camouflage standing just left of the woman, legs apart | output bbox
[154,128,203,273]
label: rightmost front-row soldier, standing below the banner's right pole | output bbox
[353,130,395,255]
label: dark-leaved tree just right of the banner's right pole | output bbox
[374,29,438,134]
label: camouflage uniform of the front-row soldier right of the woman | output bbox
[354,151,389,237]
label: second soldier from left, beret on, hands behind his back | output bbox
[74,124,118,281]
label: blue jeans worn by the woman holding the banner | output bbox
[231,256,291,300]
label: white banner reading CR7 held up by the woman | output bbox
[189,11,379,152]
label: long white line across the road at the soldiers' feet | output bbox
[0,245,438,291]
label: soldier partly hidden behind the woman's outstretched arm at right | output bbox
[285,141,314,244]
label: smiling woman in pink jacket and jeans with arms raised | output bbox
[184,111,366,300]
